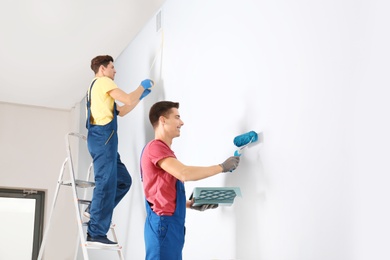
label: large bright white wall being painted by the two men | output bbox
[98,0,390,260]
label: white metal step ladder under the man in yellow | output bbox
[37,132,124,260]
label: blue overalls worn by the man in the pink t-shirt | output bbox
[144,180,186,260]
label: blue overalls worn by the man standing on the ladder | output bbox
[86,80,132,238]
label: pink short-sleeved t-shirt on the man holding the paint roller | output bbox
[141,140,177,216]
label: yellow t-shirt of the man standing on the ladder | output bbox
[88,77,118,125]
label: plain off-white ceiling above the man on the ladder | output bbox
[0,0,165,109]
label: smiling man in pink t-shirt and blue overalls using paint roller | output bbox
[141,101,240,260]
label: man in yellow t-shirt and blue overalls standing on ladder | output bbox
[84,55,154,246]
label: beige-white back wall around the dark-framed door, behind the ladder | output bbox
[0,103,79,259]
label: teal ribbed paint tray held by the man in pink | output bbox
[190,187,241,206]
